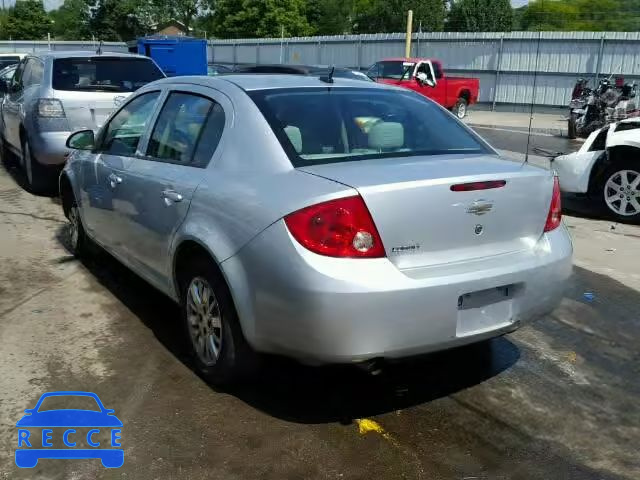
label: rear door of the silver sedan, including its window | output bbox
[120,85,231,288]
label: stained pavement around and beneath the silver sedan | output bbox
[0,143,640,480]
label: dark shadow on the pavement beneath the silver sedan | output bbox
[58,227,520,423]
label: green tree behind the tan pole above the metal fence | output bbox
[355,0,447,33]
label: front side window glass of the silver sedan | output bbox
[101,92,160,156]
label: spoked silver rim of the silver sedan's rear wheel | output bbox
[186,277,222,366]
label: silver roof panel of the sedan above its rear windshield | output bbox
[153,73,398,91]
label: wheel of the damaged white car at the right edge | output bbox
[599,160,640,223]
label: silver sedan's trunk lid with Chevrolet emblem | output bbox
[299,155,553,269]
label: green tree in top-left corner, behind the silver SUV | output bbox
[0,0,51,40]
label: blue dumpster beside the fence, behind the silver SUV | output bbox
[135,35,207,77]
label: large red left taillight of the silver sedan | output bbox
[284,196,385,258]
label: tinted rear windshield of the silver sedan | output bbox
[250,88,490,166]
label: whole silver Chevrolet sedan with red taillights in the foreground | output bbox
[60,75,572,382]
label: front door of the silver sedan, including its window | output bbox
[81,91,160,254]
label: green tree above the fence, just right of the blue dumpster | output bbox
[213,0,313,38]
